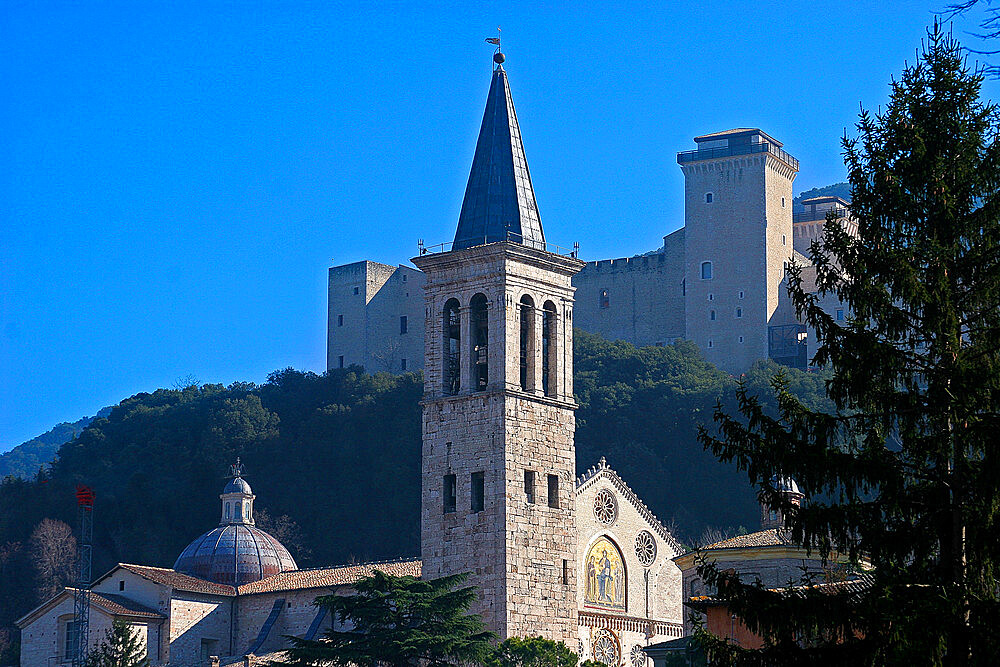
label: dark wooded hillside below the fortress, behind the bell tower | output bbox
[0,332,824,652]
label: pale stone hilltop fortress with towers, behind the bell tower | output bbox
[327,128,851,373]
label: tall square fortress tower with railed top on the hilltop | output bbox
[677,128,799,372]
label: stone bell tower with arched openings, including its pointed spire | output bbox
[413,49,584,646]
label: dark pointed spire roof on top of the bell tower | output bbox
[453,58,545,250]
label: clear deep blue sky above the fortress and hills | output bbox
[0,0,996,450]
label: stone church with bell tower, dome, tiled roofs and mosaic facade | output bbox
[18,50,684,667]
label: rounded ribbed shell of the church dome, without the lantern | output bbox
[174,523,298,586]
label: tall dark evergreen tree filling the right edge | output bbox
[700,25,1000,665]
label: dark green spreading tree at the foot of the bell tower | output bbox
[278,570,495,667]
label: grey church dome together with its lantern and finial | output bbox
[174,459,298,586]
